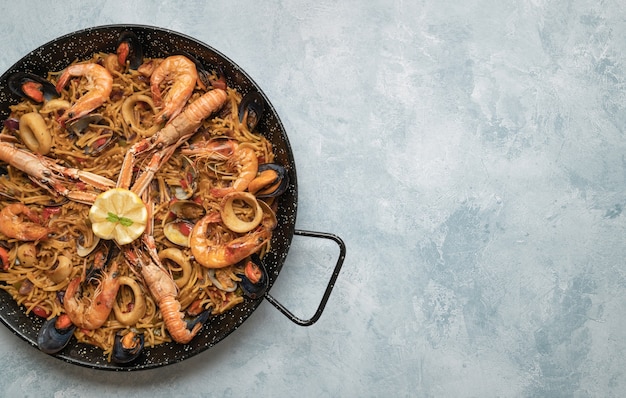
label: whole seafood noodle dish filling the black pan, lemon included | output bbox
[0,32,289,364]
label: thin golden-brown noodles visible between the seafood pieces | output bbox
[0,53,274,356]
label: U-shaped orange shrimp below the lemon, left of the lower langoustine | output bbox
[63,261,120,330]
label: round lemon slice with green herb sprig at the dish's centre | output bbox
[89,188,148,245]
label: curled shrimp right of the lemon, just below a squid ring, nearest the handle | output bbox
[189,208,276,268]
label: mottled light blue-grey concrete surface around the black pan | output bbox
[0,0,626,398]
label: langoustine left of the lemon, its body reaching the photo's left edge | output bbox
[0,142,115,204]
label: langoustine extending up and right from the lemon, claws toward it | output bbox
[118,89,227,195]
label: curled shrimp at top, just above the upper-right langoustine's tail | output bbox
[150,55,198,122]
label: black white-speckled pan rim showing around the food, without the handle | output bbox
[0,25,297,371]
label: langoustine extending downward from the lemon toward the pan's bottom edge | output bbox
[124,235,209,344]
